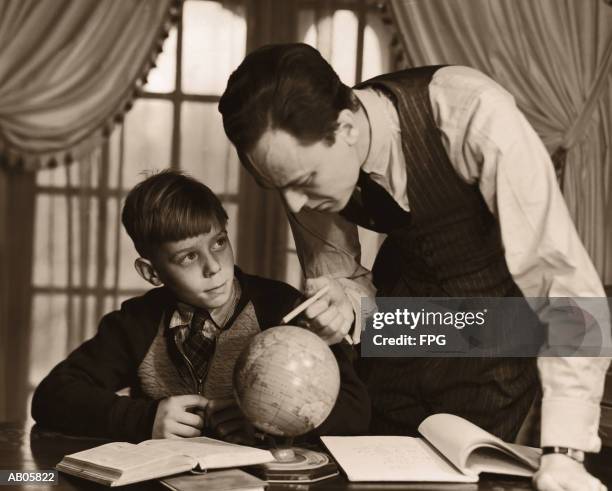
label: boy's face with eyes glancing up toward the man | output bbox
[140,224,234,309]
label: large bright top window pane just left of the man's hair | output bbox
[182,0,246,95]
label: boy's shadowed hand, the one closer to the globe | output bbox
[206,399,255,445]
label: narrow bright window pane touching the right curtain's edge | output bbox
[361,13,391,80]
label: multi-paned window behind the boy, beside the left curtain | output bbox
[29,0,246,387]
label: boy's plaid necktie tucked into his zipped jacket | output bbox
[183,310,218,382]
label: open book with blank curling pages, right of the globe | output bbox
[321,414,540,482]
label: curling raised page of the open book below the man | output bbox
[419,413,540,476]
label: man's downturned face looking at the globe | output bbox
[247,127,360,213]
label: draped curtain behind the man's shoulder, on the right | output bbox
[388,0,612,284]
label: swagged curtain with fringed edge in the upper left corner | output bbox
[0,0,176,169]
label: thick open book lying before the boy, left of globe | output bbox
[56,437,274,486]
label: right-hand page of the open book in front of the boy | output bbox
[138,437,274,470]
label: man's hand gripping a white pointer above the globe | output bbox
[304,276,355,344]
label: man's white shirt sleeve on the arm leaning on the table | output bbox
[437,69,610,452]
